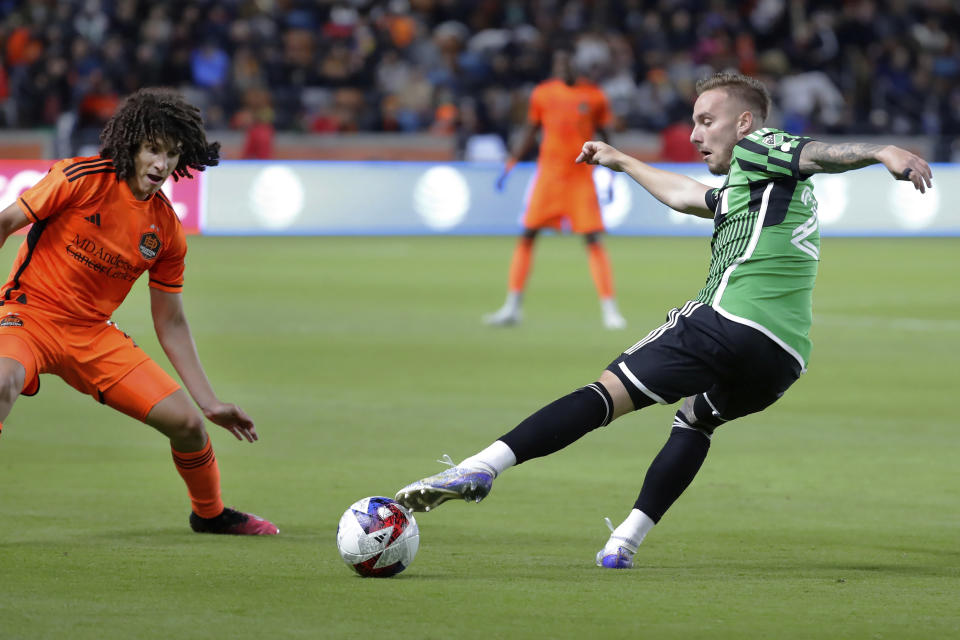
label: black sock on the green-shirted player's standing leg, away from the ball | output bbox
[634,427,710,522]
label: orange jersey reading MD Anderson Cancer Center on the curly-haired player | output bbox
[2,156,187,323]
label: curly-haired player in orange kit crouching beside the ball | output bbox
[0,89,278,535]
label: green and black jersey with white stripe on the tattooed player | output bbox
[697,129,820,370]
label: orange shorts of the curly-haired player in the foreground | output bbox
[0,302,180,420]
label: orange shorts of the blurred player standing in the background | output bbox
[523,167,603,233]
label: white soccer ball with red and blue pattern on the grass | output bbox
[337,496,420,578]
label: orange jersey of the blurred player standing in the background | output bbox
[527,80,611,173]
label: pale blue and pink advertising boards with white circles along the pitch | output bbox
[0,160,960,236]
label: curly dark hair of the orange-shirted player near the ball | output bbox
[100,88,220,180]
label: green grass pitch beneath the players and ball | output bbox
[0,237,960,640]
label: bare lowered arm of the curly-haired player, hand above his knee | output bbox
[150,287,258,442]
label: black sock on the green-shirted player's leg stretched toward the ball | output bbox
[499,383,613,464]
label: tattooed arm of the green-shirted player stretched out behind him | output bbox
[800,141,933,193]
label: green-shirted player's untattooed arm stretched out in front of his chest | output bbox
[577,140,713,218]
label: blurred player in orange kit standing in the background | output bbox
[484,49,627,329]
